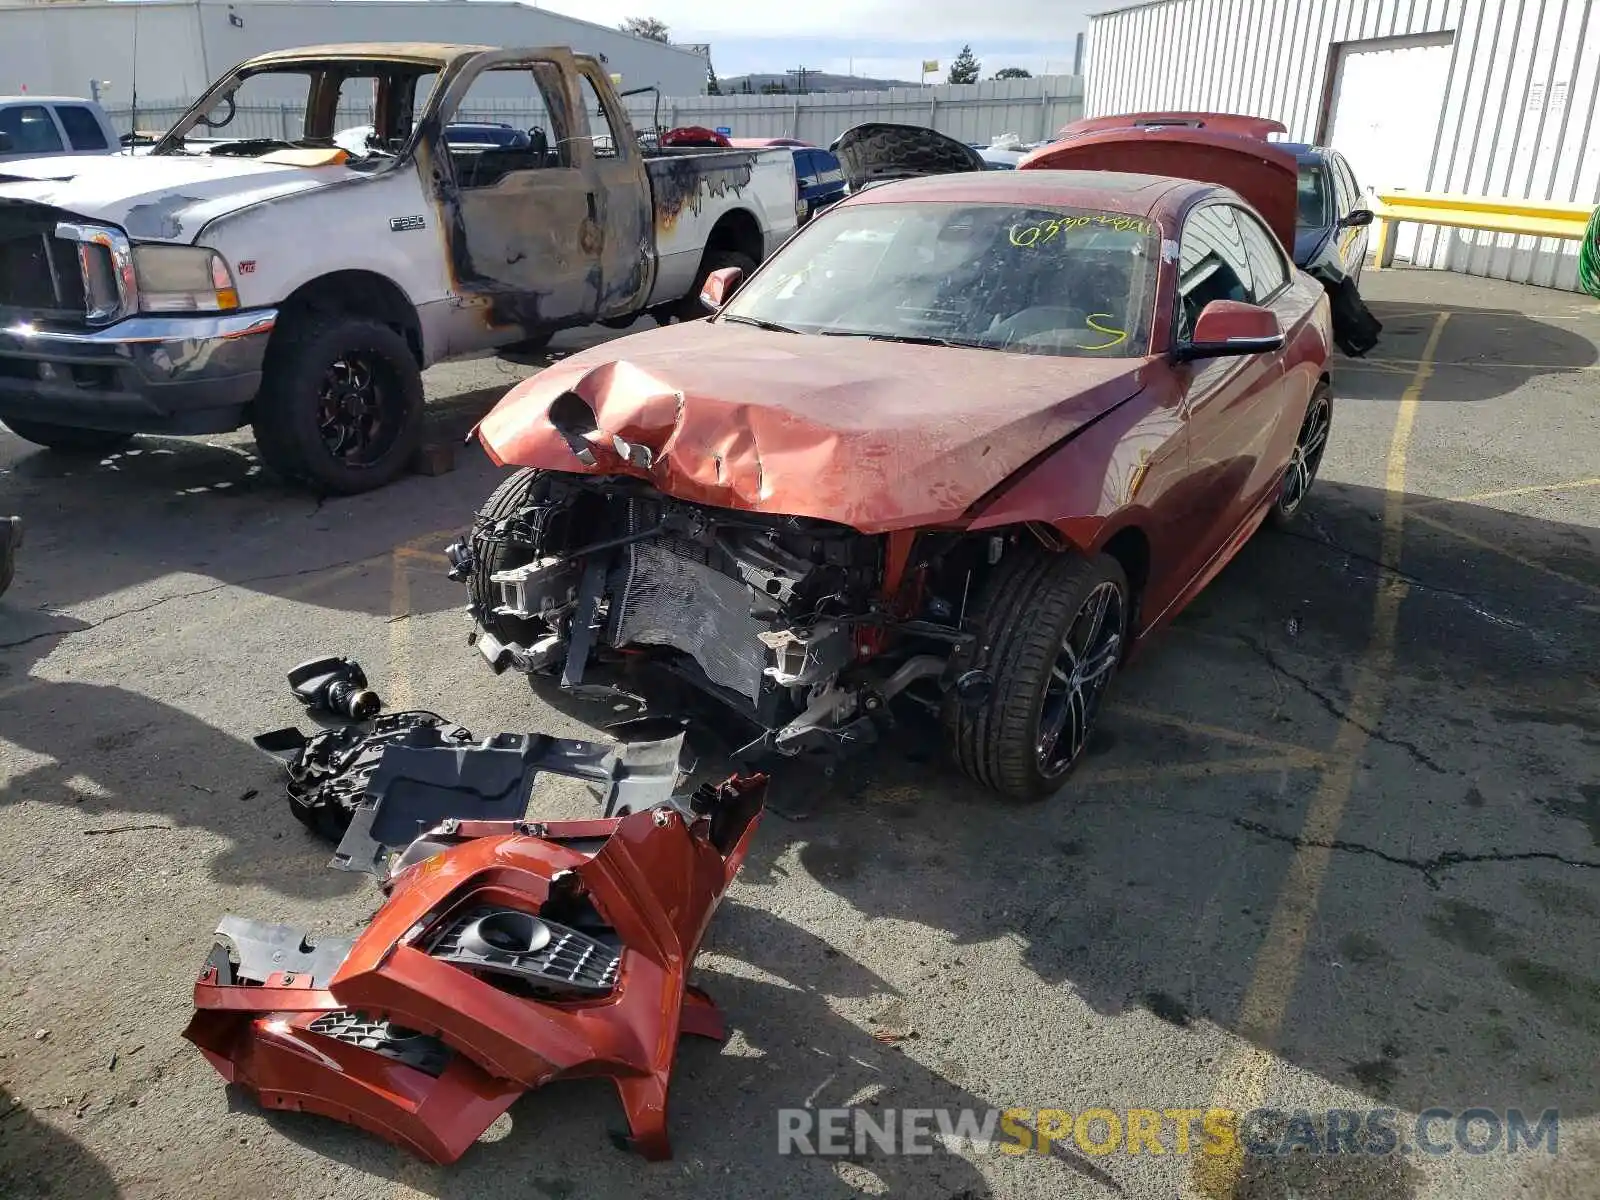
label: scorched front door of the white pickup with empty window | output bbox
[440,51,603,341]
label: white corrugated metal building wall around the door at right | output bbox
[1085,0,1600,290]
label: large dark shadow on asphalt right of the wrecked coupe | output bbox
[521,483,1600,1139]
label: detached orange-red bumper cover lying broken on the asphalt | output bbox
[184,776,766,1163]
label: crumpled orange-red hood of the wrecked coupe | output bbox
[477,322,1152,533]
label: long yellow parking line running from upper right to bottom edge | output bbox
[1194,312,1450,1200]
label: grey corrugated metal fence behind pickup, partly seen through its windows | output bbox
[107,75,1083,146]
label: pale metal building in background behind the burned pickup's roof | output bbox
[0,0,707,112]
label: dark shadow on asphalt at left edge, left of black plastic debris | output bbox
[0,624,360,899]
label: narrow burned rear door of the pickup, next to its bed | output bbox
[574,59,656,318]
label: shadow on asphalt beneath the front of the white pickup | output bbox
[0,392,501,624]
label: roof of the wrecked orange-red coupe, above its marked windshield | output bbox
[845,171,1203,216]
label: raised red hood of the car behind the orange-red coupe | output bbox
[1018,112,1299,251]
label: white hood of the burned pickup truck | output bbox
[0,155,353,242]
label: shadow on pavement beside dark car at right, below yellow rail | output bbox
[1333,299,1600,405]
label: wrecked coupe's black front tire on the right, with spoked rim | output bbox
[946,550,1133,802]
